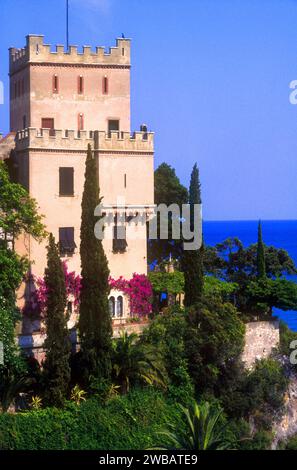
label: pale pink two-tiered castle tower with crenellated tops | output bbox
[0,35,154,319]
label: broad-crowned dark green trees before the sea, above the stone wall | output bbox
[204,237,297,316]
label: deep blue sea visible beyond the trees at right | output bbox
[203,220,297,331]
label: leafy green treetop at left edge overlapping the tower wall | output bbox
[0,162,45,240]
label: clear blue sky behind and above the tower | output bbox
[0,0,297,220]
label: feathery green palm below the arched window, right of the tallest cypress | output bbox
[113,331,165,394]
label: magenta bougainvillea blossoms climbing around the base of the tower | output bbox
[25,261,153,317]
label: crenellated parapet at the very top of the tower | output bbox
[9,35,130,73]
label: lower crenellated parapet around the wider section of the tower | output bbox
[15,127,154,154]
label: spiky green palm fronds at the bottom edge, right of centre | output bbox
[158,402,230,450]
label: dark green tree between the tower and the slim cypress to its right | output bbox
[148,163,188,264]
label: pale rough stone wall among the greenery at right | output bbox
[242,321,279,369]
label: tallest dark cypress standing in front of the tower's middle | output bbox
[79,145,112,380]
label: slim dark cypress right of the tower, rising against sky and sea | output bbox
[182,163,204,307]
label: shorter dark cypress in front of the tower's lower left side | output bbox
[44,234,70,407]
